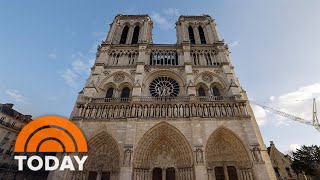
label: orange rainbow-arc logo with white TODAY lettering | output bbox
[14,116,88,171]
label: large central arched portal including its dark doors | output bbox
[133,122,194,180]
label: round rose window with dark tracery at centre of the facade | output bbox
[149,77,179,97]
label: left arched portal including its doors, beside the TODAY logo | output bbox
[84,131,120,180]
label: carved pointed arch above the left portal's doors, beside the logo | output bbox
[85,131,120,173]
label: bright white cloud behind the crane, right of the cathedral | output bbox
[252,83,320,126]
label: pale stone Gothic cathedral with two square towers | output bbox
[49,15,276,180]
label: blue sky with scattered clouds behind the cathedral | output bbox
[0,0,320,153]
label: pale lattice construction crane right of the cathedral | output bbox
[250,98,320,132]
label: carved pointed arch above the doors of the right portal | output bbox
[205,127,251,168]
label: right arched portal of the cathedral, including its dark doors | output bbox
[206,127,253,180]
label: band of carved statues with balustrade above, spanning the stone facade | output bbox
[74,96,247,119]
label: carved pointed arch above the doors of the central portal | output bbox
[133,122,193,169]
